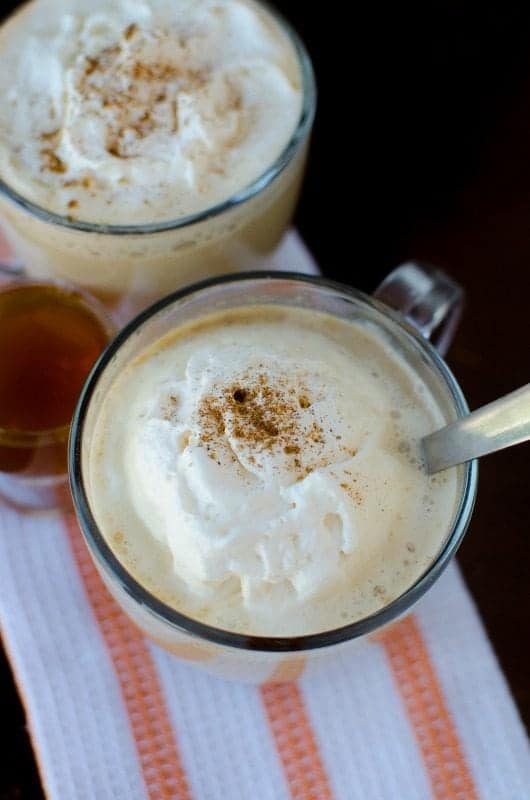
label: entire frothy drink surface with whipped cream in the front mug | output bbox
[88,307,457,636]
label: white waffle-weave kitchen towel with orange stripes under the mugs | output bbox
[0,235,530,800]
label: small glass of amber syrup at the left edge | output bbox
[0,280,115,510]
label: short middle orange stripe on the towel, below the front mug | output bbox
[260,683,333,800]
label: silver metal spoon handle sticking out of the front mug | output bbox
[421,383,530,474]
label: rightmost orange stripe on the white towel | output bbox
[378,615,478,800]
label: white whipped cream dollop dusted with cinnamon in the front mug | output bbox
[125,345,382,606]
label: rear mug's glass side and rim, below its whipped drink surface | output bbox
[0,0,316,323]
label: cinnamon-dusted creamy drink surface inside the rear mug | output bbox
[0,0,302,224]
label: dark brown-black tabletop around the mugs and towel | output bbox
[0,0,530,800]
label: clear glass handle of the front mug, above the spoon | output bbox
[374,261,464,355]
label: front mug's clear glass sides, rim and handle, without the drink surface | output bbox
[69,264,477,683]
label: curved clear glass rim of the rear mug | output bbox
[0,0,317,236]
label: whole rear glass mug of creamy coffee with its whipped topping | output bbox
[0,0,312,314]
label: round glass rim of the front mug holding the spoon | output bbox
[68,271,478,653]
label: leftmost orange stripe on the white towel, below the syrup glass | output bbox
[64,514,191,800]
